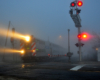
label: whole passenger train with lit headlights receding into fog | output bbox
[20,35,66,62]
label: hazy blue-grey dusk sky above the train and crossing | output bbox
[0,0,100,55]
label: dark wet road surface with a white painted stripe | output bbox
[0,58,100,80]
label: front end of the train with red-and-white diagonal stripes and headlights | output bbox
[20,35,36,61]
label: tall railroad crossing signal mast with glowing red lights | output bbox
[69,0,83,61]
